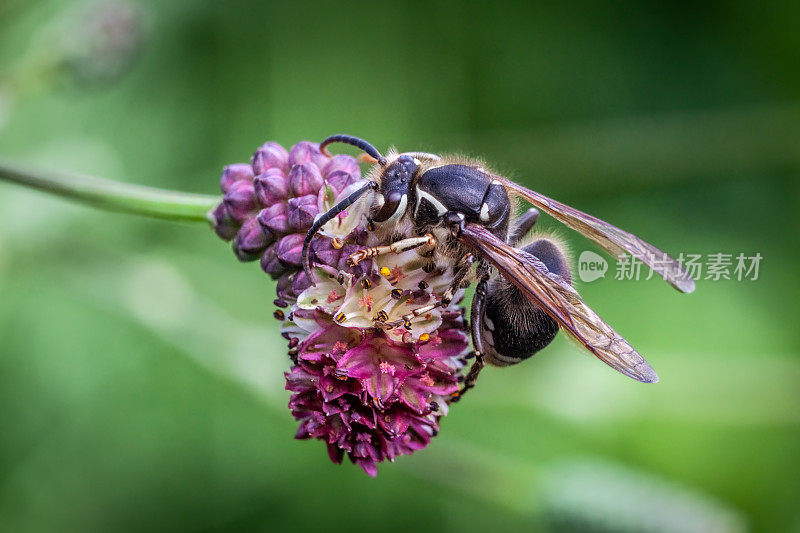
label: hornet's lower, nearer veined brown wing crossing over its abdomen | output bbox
[459,224,658,383]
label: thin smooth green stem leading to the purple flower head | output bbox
[0,159,220,222]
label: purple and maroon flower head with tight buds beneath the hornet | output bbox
[212,142,468,476]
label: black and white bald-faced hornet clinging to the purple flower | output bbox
[302,135,694,394]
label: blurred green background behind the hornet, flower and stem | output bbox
[0,0,800,532]
